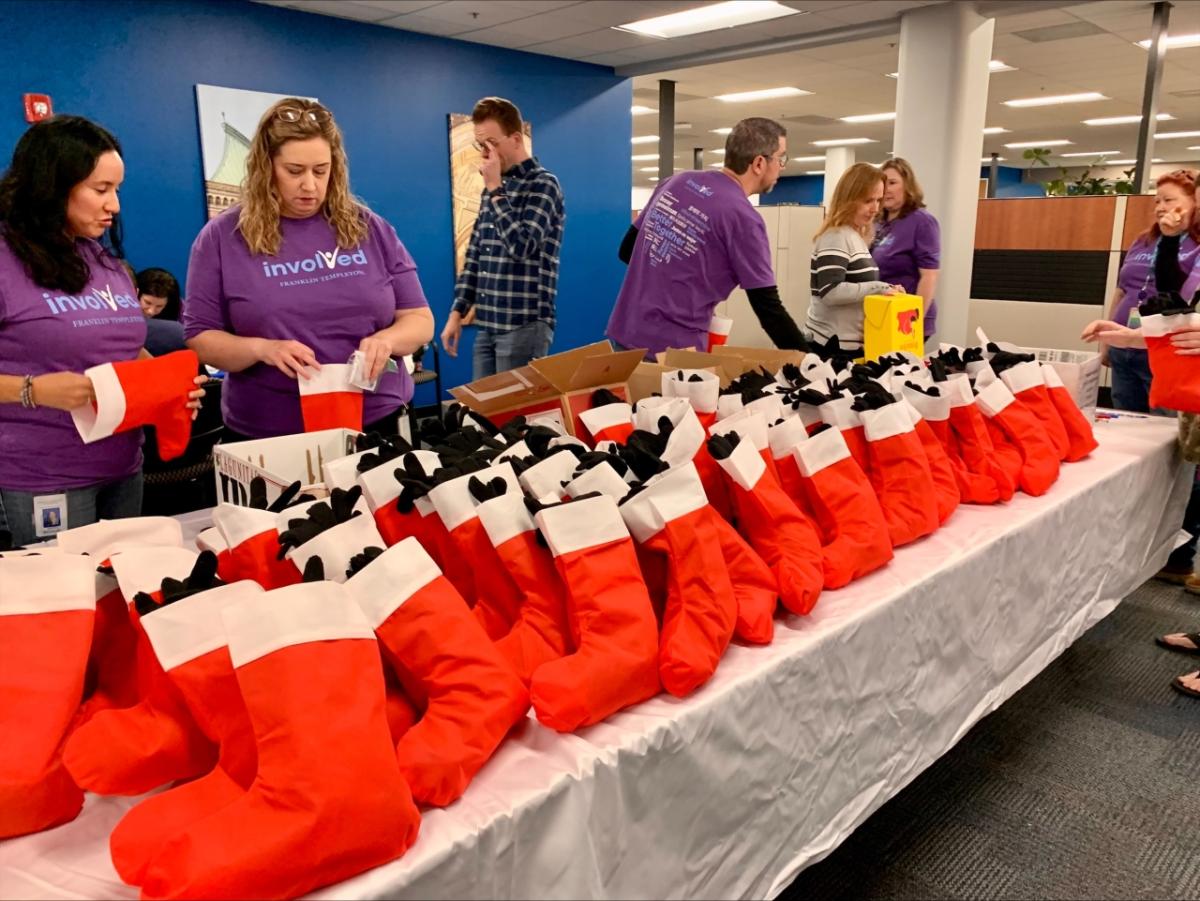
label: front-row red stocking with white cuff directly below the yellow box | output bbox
[862,403,937,547]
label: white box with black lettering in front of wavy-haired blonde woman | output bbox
[212,428,359,506]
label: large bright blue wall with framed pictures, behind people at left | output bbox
[0,0,631,386]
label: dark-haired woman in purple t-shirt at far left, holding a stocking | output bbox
[0,115,203,545]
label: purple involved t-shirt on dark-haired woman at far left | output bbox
[0,238,146,494]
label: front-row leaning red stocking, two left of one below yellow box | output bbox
[708,436,824,615]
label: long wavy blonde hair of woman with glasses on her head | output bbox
[238,97,367,257]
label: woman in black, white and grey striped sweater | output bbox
[805,163,901,355]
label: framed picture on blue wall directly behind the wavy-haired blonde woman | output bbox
[196,84,317,218]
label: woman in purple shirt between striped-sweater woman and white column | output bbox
[871,157,942,341]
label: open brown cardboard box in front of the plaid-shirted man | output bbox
[450,341,646,438]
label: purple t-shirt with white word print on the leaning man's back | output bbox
[607,172,775,353]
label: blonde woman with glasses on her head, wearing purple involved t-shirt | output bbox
[184,97,433,440]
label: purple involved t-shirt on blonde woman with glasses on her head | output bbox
[184,206,428,438]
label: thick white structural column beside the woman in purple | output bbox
[892,2,995,344]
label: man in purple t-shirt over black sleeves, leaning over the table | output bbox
[606,118,808,354]
